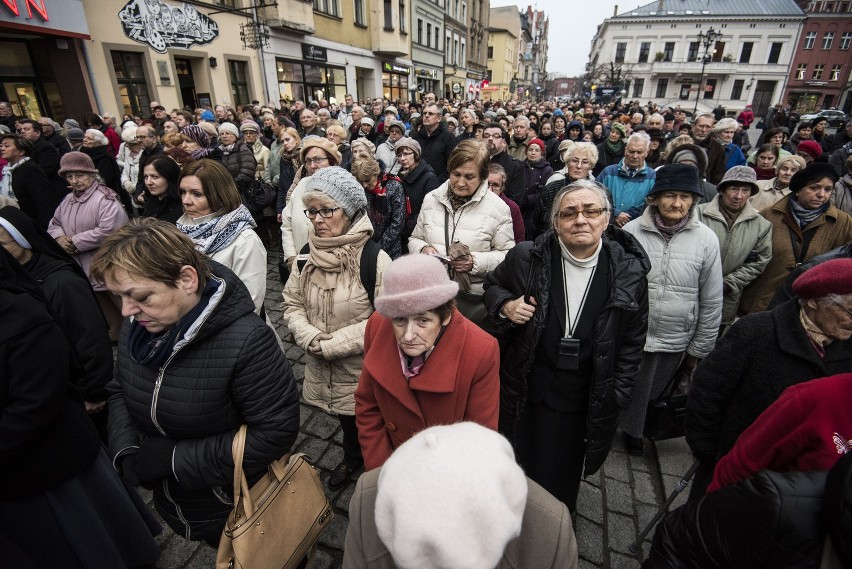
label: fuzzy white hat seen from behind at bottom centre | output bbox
[376,423,527,569]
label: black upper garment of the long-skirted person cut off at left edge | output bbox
[0,280,100,501]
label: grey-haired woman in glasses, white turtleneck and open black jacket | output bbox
[485,180,650,511]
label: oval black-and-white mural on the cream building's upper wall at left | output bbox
[118,0,219,53]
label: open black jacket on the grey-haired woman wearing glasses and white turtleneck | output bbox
[483,227,651,476]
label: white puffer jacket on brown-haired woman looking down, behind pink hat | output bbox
[408,180,515,296]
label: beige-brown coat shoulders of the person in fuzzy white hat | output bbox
[343,468,578,569]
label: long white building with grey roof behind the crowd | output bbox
[588,0,805,116]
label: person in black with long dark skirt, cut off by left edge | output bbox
[0,250,160,569]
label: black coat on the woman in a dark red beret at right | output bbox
[685,300,852,458]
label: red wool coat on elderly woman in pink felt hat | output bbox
[355,310,500,470]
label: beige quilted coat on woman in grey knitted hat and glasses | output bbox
[283,215,391,415]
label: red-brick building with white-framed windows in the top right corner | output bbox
[783,0,852,113]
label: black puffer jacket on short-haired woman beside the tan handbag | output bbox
[109,261,299,537]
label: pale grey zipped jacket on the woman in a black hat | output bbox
[624,206,722,358]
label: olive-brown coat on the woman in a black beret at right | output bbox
[739,194,852,315]
